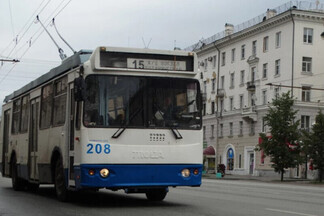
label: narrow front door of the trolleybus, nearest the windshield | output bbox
[68,83,75,185]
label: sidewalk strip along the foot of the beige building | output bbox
[202,173,324,187]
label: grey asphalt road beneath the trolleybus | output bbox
[0,177,324,216]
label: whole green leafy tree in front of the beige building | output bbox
[256,92,300,181]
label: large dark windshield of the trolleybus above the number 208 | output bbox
[83,75,201,129]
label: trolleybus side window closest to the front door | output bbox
[53,76,67,127]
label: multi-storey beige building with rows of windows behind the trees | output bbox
[186,1,324,177]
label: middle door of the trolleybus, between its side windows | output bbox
[28,98,39,180]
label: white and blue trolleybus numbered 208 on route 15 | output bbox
[0,47,203,201]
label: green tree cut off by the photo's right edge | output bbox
[305,111,324,182]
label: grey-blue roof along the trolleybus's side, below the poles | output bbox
[4,50,92,103]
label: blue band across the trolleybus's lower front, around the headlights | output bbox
[74,164,202,189]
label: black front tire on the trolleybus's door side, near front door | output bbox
[54,159,69,202]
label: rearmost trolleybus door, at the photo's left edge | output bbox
[2,109,10,176]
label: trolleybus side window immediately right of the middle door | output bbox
[40,83,53,129]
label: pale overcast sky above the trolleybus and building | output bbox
[0,0,302,104]
